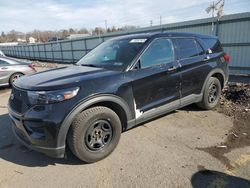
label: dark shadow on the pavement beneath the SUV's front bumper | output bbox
[0,114,84,167]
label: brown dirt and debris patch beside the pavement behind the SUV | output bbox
[201,83,250,174]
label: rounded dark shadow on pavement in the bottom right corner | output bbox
[191,169,250,188]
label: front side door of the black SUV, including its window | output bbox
[132,38,180,112]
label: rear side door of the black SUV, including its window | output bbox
[174,38,210,98]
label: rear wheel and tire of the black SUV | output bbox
[197,77,221,110]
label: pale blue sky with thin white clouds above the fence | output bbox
[0,0,250,32]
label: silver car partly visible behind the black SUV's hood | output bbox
[0,56,36,86]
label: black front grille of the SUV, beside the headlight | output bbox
[9,87,30,114]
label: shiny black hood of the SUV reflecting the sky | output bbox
[14,66,116,91]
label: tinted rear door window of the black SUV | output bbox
[175,38,203,59]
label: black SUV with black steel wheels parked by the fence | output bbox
[8,33,230,162]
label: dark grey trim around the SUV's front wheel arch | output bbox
[57,95,132,147]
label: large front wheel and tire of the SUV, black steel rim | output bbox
[67,106,122,163]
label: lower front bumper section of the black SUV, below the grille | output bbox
[8,105,65,158]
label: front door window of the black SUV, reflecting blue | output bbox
[140,38,174,68]
